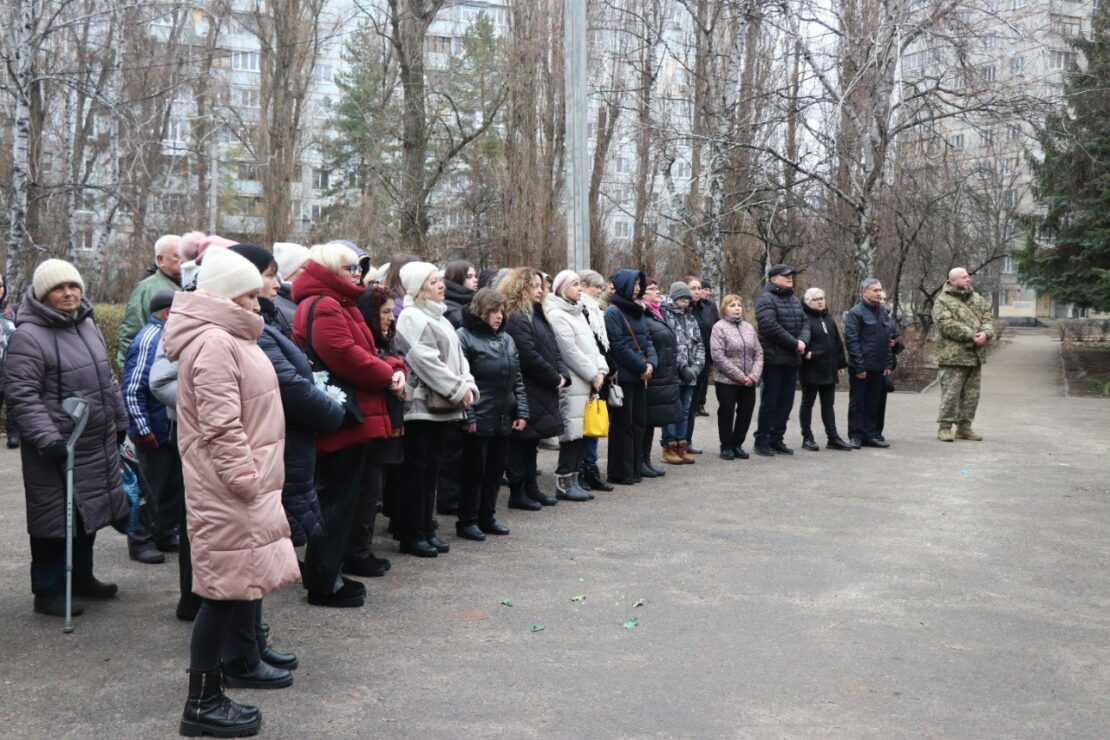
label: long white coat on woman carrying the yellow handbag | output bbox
[544,295,609,442]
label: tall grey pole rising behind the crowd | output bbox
[563,0,589,272]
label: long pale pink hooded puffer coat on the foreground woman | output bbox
[164,293,301,601]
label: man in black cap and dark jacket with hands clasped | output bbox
[755,265,809,456]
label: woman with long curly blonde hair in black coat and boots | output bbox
[497,267,571,511]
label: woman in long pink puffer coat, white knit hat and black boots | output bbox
[163,249,300,737]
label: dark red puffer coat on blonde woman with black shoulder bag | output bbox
[293,260,405,454]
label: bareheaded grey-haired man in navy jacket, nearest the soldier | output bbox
[844,277,895,447]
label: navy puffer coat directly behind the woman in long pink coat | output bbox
[259,298,344,546]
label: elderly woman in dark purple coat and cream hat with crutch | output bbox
[4,260,129,617]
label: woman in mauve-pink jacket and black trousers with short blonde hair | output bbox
[709,294,763,460]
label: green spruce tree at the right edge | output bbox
[1018,2,1110,311]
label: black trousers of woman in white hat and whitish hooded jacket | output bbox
[393,422,454,541]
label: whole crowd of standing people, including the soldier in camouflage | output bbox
[0,232,993,736]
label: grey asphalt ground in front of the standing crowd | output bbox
[0,334,1110,738]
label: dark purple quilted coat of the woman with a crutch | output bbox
[4,287,129,537]
